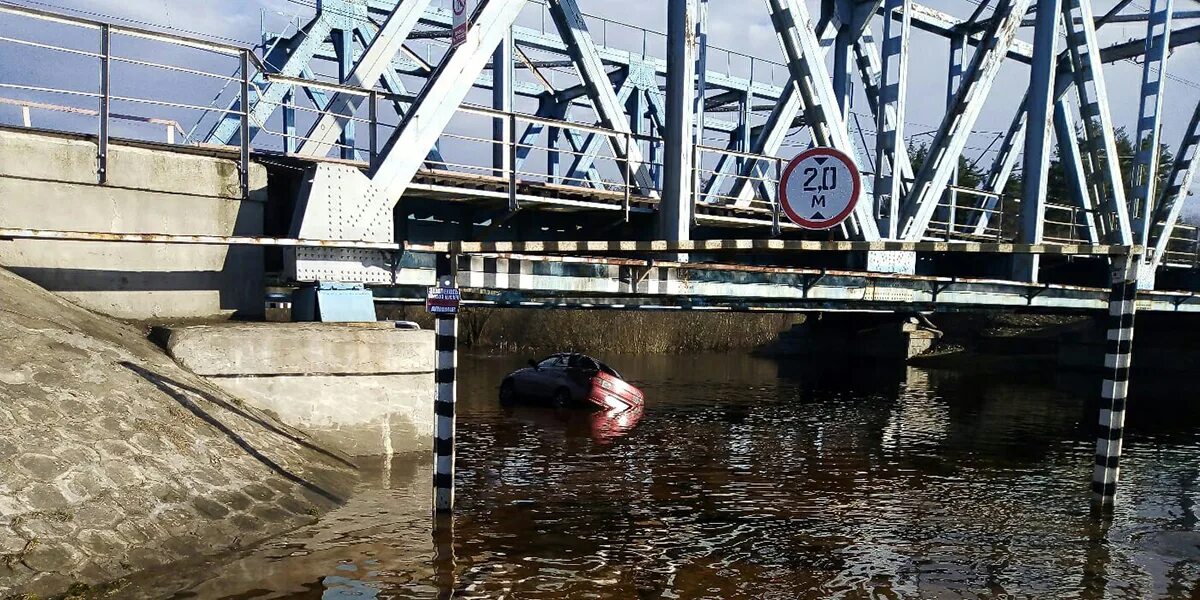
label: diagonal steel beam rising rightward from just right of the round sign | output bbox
[900,0,1030,240]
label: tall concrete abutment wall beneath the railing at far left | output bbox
[0,127,266,319]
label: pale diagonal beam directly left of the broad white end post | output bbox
[298,0,431,156]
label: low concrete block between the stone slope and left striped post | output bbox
[157,323,434,456]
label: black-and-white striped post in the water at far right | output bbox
[1092,254,1141,509]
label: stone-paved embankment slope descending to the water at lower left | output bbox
[0,269,355,599]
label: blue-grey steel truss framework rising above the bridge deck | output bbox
[184,0,1200,281]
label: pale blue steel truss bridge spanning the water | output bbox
[0,0,1200,311]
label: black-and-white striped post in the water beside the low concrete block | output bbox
[433,254,458,514]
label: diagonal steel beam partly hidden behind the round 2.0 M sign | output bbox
[767,0,880,241]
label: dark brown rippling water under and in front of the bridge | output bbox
[126,356,1200,599]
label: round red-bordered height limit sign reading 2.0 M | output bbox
[779,148,863,229]
